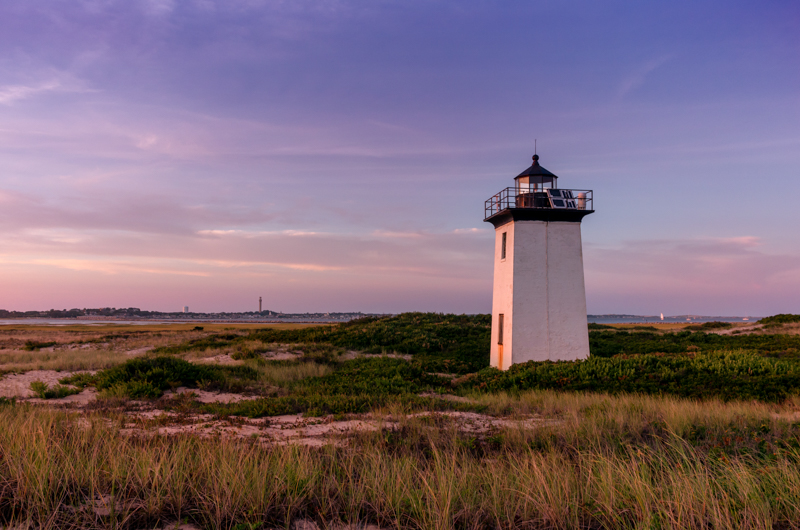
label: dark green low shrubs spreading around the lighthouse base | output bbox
[47,313,800,404]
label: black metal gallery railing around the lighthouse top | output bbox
[485,187,594,219]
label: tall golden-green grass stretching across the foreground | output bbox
[0,392,800,529]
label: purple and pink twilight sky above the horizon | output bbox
[0,0,800,315]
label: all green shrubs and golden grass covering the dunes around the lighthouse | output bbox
[0,313,800,529]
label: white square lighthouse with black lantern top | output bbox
[484,155,594,370]
